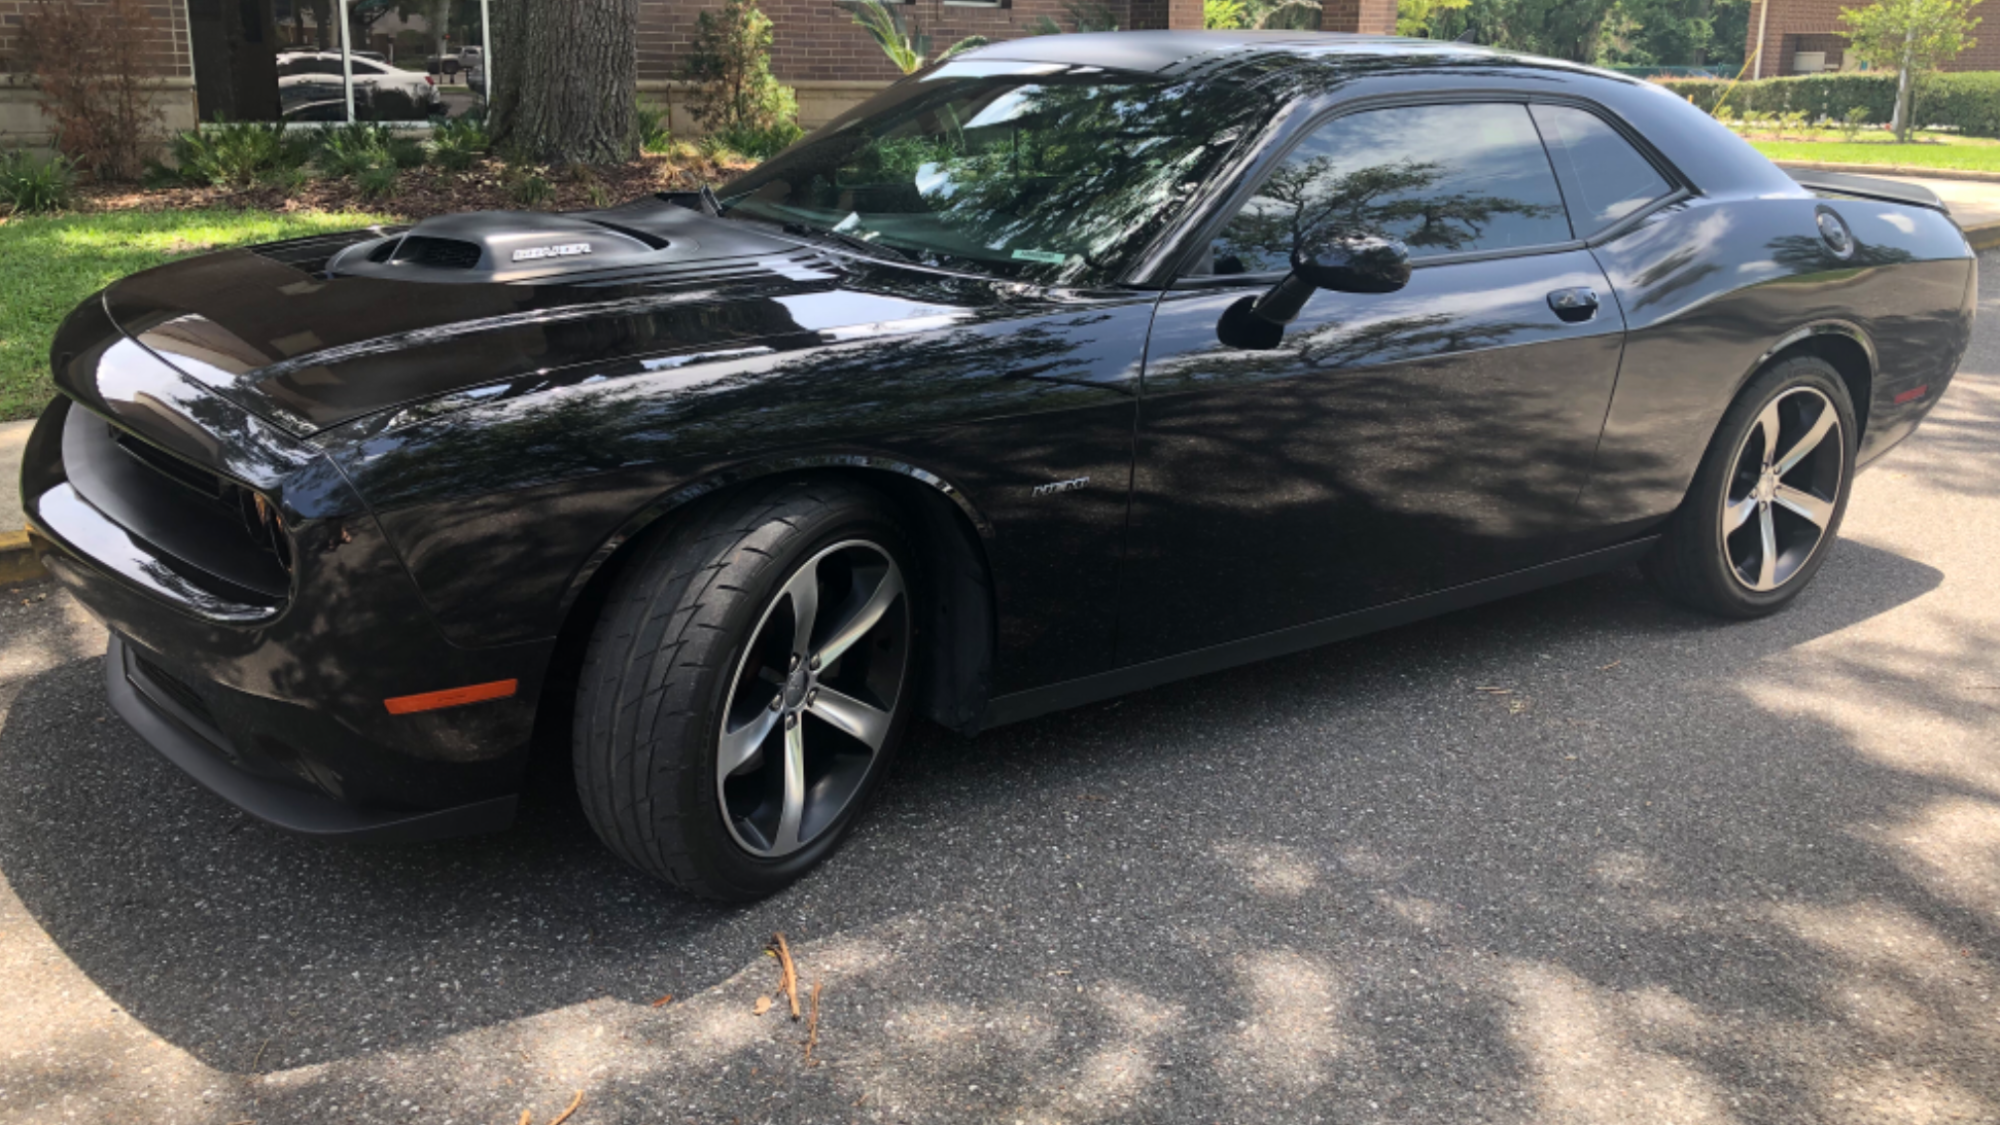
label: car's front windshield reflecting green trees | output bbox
[720,60,1254,284]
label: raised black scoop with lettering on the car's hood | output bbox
[326,198,824,284]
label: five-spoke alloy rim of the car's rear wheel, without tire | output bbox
[1722,386,1846,593]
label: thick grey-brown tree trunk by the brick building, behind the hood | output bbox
[488,0,638,164]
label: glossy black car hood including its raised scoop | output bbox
[82,198,1026,436]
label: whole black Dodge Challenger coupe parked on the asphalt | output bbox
[22,32,1976,899]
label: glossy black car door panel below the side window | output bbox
[1120,250,1622,663]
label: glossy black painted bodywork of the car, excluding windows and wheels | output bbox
[24,32,1974,835]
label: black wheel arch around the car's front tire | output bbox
[536,452,998,747]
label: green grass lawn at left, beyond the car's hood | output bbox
[0,210,382,420]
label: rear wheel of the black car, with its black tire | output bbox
[1642,356,1860,619]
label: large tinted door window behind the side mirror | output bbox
[1202,104,1572,274]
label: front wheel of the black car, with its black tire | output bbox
[574,480,920,901]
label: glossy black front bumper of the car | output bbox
[22,302,552,839]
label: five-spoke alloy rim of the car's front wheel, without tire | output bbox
[716,540,910,859]
